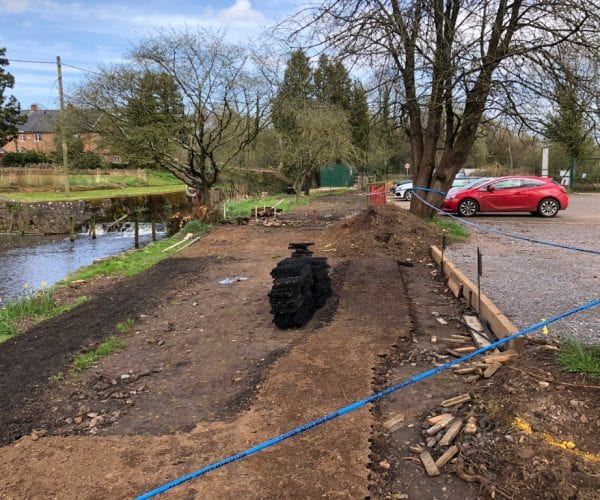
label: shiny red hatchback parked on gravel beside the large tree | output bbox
[442,175,569,217]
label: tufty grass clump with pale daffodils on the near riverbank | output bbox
[0,288,88,343]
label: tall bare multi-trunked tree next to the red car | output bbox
[282,0,600,216]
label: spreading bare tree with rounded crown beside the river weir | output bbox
[74,30,270,207]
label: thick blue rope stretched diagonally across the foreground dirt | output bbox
[136,298,600,500]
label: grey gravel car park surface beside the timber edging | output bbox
[446,204,600,343]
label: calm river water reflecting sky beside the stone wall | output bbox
[0,224,166,307]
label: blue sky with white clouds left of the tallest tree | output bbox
[0,0,298,109]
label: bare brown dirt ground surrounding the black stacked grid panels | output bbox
[0,195,600,499]
